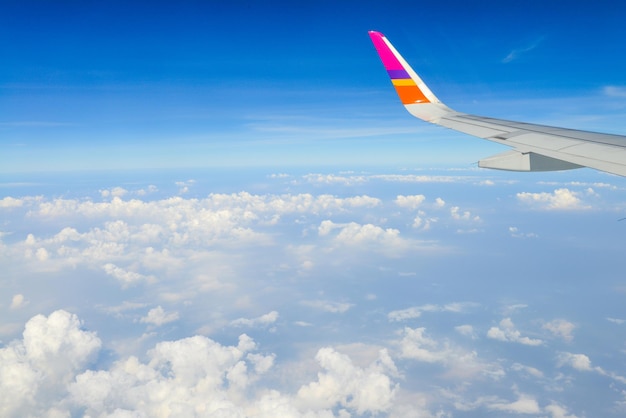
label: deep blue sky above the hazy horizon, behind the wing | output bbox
[0,1,626,173]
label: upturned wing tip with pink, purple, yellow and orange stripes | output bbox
[369,31,441,106]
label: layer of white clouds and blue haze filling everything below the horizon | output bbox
[0,169,626,418]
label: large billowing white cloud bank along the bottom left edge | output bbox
[0,311,398,417]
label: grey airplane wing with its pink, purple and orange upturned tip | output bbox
[369,31,626,176]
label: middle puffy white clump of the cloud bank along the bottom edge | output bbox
[70,334,273,416]
